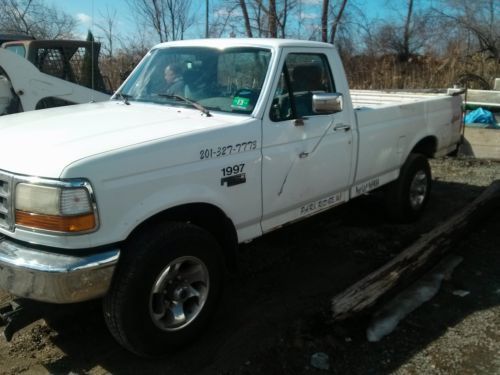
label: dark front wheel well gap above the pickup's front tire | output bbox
[129,203,238,268]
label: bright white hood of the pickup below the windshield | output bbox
[0,101,240,177]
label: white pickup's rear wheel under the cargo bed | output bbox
[385,154,432,223]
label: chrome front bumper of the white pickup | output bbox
[0,235,120,303]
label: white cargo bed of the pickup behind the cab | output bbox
[351,90,461,188]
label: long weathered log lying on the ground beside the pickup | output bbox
[331,180,500,320]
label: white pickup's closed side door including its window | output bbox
[262,49,353,232]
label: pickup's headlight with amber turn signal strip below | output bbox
[14,180,97,233]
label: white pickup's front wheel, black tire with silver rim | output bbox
[103,222,224,357]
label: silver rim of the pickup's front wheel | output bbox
[149,256,209,331]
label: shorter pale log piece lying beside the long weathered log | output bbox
[366,255,463,342]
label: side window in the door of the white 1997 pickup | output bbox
[270,53,335,121]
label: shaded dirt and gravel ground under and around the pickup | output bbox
[0,159,500,375]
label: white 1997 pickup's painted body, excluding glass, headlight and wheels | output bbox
[0,39,461,353]
